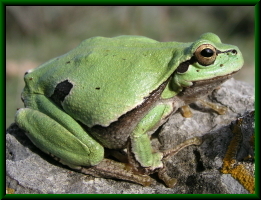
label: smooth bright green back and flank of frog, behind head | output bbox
[25,36,186,127]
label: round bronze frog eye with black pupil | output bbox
[194,44,217,66]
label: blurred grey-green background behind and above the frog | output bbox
[6,6,255,126]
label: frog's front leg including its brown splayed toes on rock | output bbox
[128,104,201,188]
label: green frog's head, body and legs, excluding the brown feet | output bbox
[16,33,243,188]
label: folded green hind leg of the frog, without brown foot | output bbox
[15,95,104,167]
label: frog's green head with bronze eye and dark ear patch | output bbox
[170,33,244,100]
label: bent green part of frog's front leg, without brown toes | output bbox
[131,104,171,169]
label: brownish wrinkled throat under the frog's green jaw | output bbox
[178,71,237,103]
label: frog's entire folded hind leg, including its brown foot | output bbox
[15,94,152,186]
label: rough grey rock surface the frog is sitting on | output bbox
[6,79,254,194]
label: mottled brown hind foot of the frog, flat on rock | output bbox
[79,158,153,186]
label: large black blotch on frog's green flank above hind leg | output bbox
[50,80,73,106]
